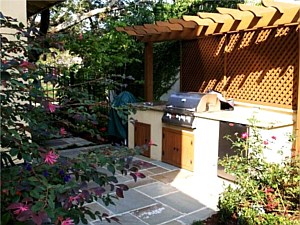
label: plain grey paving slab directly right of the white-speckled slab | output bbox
[156,192,205,213]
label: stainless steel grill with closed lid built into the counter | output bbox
[162,92,221,128]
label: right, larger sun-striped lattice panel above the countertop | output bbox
[225,27,299,108]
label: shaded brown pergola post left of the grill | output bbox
[144,42,153,102]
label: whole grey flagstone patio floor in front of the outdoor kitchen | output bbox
[40,138,215,225]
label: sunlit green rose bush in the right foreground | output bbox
[218,119,300,225]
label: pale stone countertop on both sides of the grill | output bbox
[132,102,294,129]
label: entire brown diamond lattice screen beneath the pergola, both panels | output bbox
[181,26,299,109]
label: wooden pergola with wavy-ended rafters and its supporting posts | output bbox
[116,0,300,152]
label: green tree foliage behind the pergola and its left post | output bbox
[47,0,246,100]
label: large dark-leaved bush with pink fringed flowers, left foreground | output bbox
[0,14,144,225]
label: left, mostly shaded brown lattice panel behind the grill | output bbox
[181,36,225,92]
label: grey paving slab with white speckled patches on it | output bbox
[132,203,182,225]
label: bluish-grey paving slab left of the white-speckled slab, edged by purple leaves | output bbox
[99,189,156,214]
